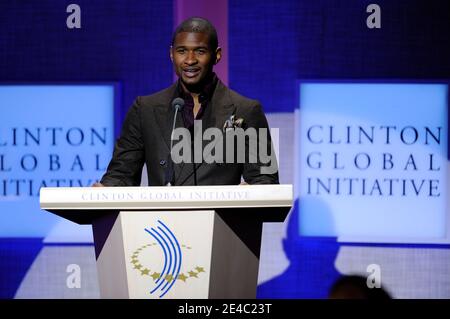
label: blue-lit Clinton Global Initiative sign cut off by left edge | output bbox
[0,84,114,242]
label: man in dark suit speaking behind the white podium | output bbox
[94,18,278,186]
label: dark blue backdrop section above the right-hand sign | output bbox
[229,0,450,112]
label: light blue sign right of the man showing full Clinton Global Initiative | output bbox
[296,83,449,243]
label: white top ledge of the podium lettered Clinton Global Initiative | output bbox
[40,184,293,223]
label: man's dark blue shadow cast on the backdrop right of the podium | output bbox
[257,198,340,299]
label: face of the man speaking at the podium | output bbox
[170,32,221,90]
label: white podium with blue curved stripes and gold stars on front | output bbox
[40,185,293,299]
